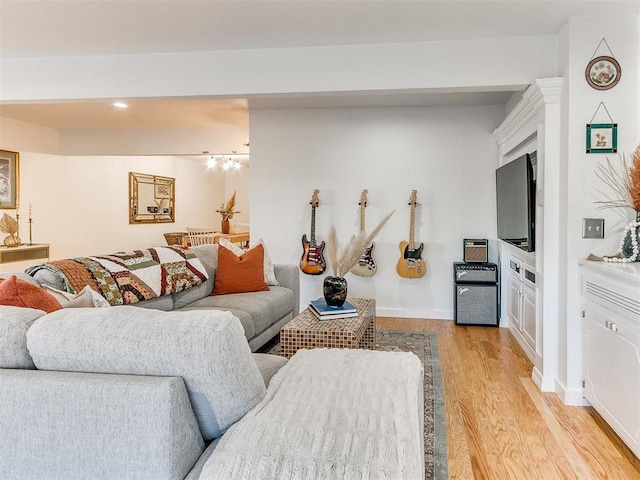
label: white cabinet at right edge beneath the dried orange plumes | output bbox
[581,260,640,456]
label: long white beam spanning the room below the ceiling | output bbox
[0,33,556,101]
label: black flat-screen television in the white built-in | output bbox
[496,152,536,252]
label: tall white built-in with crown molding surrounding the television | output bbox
[493,78,564,394]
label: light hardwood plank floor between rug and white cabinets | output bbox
[377,318,640,480]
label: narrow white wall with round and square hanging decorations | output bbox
[558,15,640,403]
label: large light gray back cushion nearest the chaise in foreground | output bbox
[27,306,265,440]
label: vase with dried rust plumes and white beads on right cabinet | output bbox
[588,145,640,263]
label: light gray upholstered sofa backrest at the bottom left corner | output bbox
[0,369,204,480]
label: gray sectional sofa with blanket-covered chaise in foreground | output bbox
[0,246,424,480]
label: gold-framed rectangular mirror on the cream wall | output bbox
[129,172,176,223]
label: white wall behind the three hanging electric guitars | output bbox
[250,106,505,318]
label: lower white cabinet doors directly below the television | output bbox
[506,255,538,356]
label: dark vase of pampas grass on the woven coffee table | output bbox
[323,212,393,306]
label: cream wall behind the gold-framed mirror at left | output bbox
[0,119,226,272]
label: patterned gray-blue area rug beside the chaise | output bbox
[262,330,449,480]
